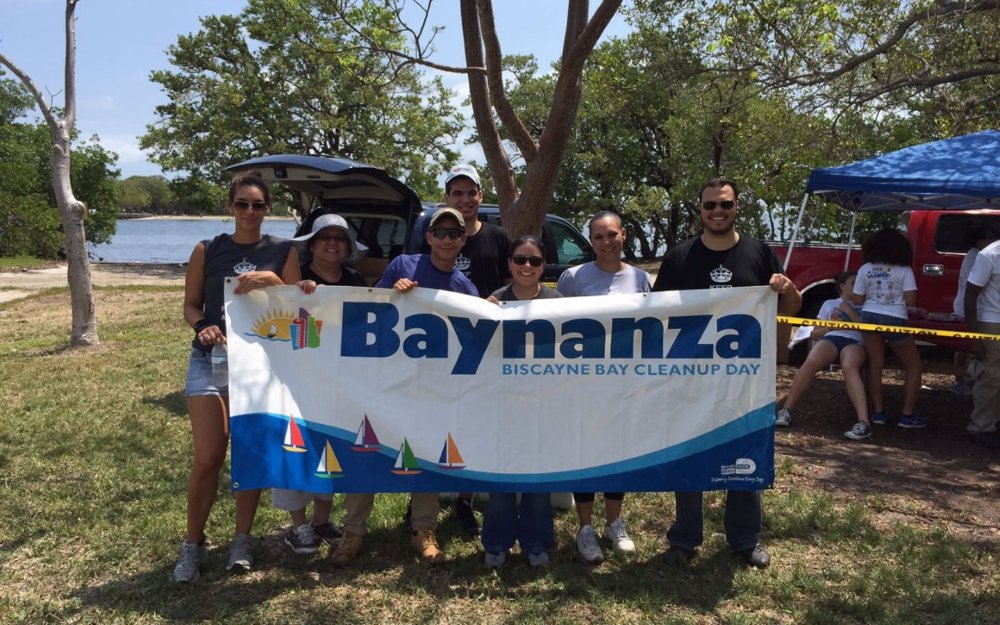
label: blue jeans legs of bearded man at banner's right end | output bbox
[667,490,763,551]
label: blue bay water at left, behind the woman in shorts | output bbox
[90,217,296,263]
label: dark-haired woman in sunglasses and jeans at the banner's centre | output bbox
[482,235,562,569]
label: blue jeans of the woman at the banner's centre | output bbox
[482,493,555,554]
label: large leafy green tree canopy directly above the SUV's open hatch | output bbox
[140,0,462,204]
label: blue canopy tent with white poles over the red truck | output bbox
[785,130,1000,268]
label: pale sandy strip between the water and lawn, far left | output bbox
[0,263,186,302]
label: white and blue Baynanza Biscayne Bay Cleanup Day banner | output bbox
[226,284,777,492]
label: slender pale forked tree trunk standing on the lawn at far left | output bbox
[0,0,100,347]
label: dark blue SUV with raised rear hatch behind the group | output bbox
[226,154,594,283]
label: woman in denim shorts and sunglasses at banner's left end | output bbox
[174,171,300,582]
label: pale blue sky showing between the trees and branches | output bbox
[0,0,627,177]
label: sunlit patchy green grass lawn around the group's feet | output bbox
[0,287,1000,625]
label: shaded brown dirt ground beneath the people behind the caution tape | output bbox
[775,365,1000,549]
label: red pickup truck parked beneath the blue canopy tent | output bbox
[771,209,1000,349]
